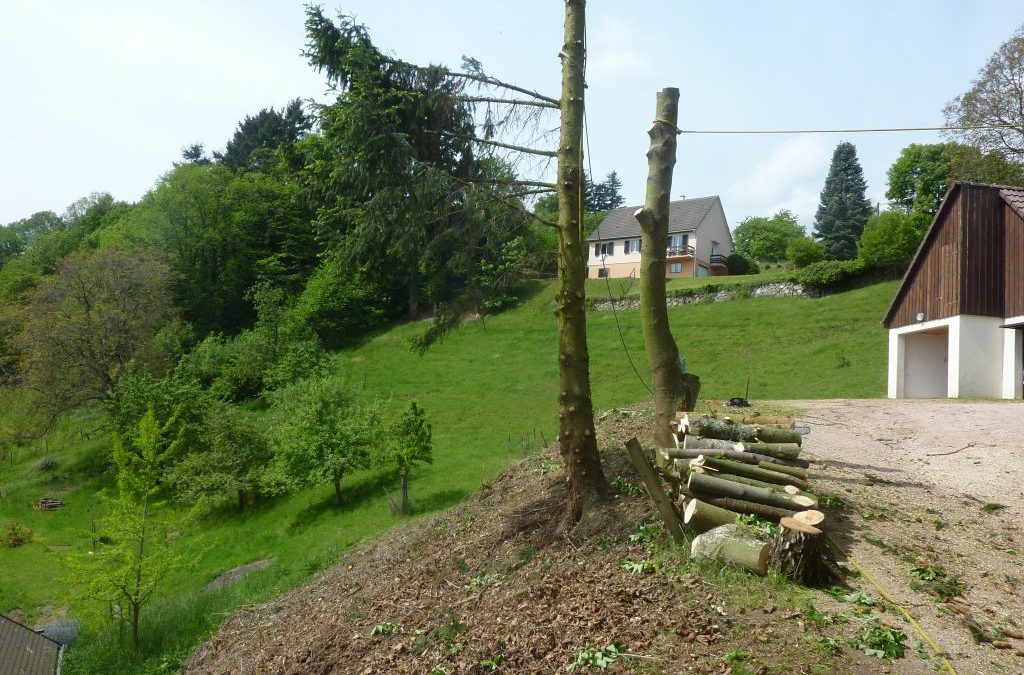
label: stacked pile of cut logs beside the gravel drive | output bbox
[634,414,830,585]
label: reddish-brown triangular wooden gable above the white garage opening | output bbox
[888,189,964,328]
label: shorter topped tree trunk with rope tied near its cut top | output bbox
[634,88,692,447]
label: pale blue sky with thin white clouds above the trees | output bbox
[0,0,1024,228]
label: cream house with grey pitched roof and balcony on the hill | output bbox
[587,196,732,279]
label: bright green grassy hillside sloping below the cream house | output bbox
[0,276,896,672]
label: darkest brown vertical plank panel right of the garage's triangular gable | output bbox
[959,185,1006,317]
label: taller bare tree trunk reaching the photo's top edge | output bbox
[555,0,608,522]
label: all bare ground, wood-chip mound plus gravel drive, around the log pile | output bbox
[183,400,1024,675]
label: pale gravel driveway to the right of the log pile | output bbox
[792,400,1024,674]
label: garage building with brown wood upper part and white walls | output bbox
[883,182,1024,398]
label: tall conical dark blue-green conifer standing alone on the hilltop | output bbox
[814,142,871,260]
